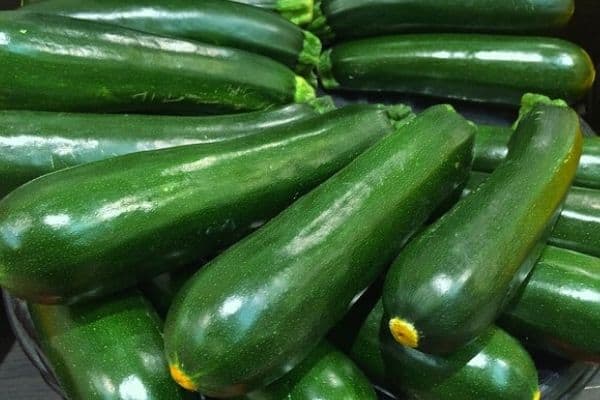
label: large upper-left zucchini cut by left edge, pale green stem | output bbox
[0,10,314,114]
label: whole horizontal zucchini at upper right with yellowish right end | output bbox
[319,34,595,105]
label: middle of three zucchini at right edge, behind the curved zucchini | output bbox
[463,172,600,257]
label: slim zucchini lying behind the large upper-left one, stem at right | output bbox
[22,0,321,73]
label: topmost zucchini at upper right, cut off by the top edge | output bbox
[309,0,575,40]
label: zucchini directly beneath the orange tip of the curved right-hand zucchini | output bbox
[349,301,539,400]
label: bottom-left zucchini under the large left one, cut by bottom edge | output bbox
[29,291,189,400]
